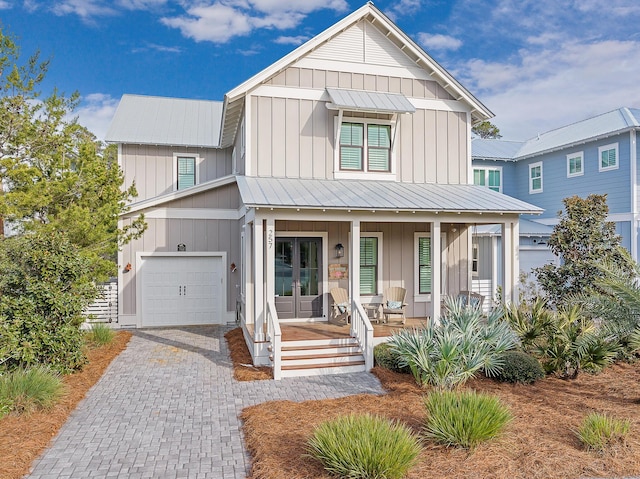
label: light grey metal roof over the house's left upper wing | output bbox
[106,95,222,148]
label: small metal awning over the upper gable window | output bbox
[327,88,416,113]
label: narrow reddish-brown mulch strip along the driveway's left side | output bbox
[0,331,131,479]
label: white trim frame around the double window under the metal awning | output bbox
[333,115,399,181]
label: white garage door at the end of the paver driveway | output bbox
[141,256,227,327]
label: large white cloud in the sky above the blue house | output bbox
[460,40,640,140]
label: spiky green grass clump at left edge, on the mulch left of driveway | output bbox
[0,366,64,417]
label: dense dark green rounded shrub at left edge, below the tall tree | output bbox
[0,233,97,373]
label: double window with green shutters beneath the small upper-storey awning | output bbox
[339,119,392,173]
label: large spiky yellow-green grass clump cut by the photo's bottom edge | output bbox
[307,414,420,479]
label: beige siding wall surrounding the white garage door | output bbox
[118,184,241,315]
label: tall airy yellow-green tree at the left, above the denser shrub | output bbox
[0,26,145,281]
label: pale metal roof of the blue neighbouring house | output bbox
[471,108,640,160]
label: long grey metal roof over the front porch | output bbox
[237,176,544,214]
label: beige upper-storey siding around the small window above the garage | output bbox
[121,145,232,202]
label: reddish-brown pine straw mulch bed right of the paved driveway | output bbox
[242,362,640,479]
